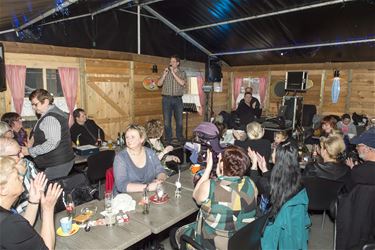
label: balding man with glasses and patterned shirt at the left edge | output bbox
[0,138,38,213]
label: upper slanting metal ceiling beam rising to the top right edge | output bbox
[180,0,355,32]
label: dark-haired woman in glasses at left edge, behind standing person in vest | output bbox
[1,112,27,146]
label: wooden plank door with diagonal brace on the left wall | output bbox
[81,59,133,140]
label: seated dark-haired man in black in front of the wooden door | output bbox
[70,108,104,146]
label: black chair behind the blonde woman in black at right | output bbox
[302,177,344,229]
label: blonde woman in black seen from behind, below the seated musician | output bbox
[233,122,271,162]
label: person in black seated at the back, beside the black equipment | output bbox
[236,92,260,127]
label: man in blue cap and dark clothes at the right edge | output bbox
[346,127,375,190]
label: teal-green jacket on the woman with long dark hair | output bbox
[261,189,311,250]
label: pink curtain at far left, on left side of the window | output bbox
[5,65,26,114]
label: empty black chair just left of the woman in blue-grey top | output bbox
[86,150,116,196]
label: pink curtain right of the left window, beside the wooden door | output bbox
[58,68,78,127]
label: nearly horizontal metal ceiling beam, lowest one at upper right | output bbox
[212,38,375,56]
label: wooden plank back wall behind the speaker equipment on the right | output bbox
[232,62,375,117]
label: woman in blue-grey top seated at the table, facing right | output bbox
[113,125,167,195]
